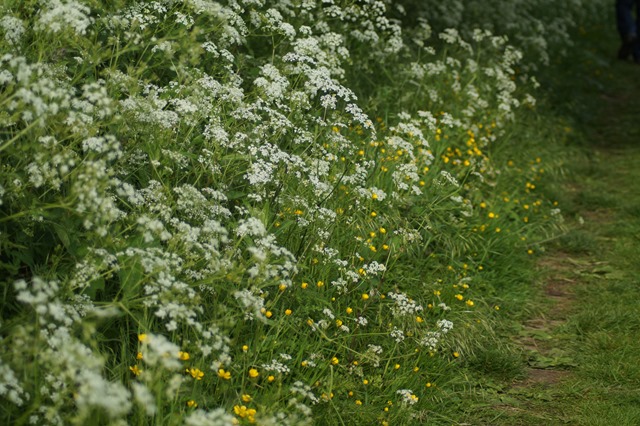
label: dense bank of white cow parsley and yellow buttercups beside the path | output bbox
[0,0,594,426]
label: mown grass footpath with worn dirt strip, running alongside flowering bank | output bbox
[462,13,640,425]
